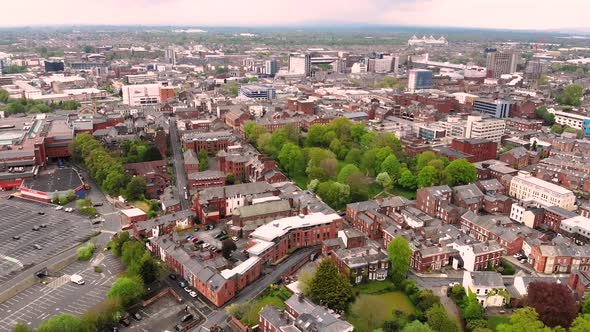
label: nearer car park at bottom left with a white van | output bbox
[0,252,123,332]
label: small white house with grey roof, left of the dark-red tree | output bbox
[463,271,508,308]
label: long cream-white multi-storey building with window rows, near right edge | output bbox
[510,171,576,211]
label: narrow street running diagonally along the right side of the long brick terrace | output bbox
[200,248,315,330]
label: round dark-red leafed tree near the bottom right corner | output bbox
[526,282,578,328]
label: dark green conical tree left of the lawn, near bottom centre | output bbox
[309,258,353,311]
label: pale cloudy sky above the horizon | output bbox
[0,0,590,29]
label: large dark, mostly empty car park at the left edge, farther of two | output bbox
[0,197,93,284]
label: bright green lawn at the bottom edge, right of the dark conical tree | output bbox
[345,292,415,332]
